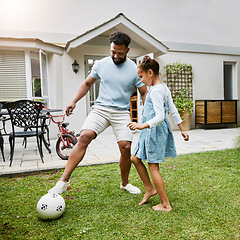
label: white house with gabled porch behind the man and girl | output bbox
[0,9,240,137]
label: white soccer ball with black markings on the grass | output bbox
[37,193,65,220]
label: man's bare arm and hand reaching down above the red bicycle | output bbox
[66,75,97,116]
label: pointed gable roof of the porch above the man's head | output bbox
[65,13,168,55]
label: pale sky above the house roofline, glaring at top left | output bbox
[0,0,240,47]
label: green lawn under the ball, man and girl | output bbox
[0,149,240,240]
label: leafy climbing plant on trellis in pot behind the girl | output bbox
[164,62,194,130]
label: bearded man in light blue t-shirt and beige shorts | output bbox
[49,32,147,194]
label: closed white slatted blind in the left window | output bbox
[0,50,27,102]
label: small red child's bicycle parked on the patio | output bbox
[48,114,80,160]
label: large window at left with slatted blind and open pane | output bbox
[0,50,49,106]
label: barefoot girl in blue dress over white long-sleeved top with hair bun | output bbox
[128,56,189,211]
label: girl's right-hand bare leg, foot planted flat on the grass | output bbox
[148,163,172,211]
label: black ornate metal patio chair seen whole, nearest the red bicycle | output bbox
[6,100,44,166]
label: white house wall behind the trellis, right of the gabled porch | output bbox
[157,52,240,129]
